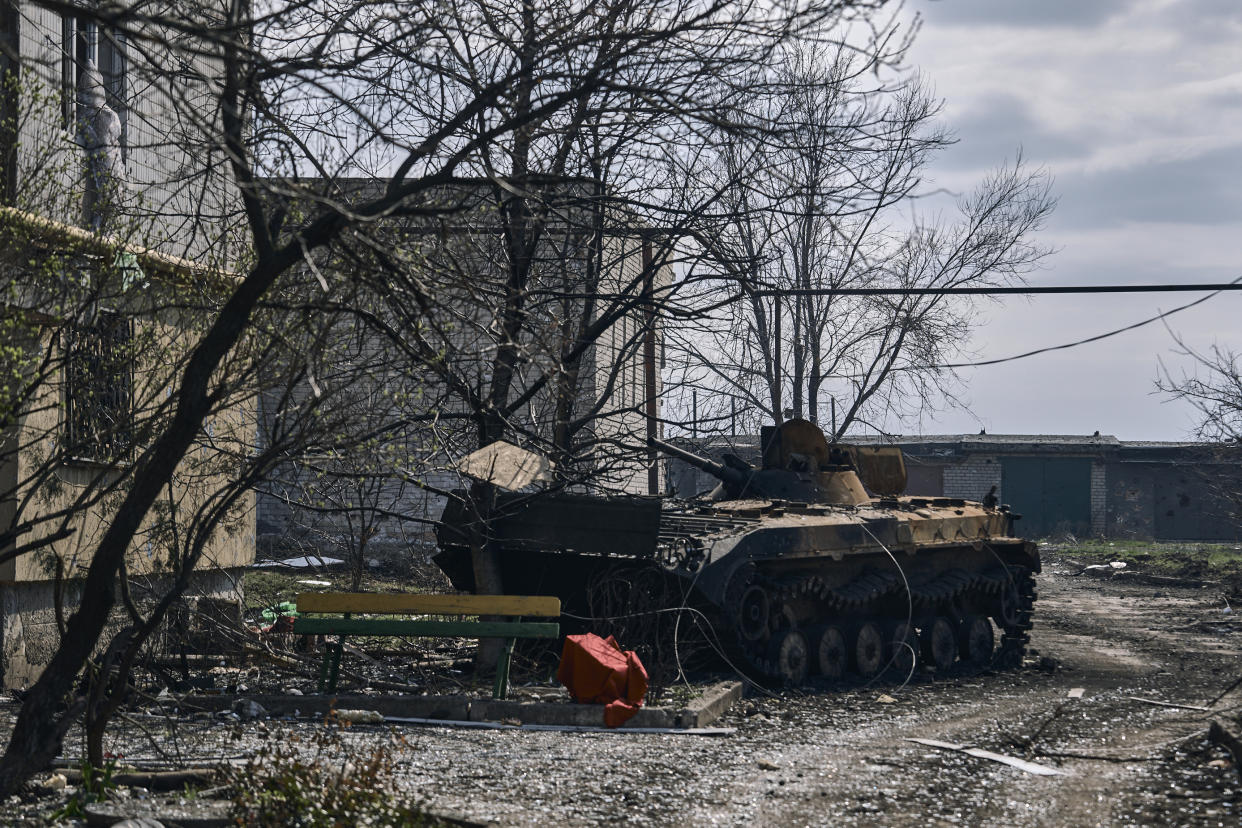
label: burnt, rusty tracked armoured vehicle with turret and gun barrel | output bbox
[436,420,1040,684]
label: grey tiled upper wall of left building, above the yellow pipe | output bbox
[16,2,245,264]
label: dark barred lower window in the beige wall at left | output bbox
[65,310,134,462]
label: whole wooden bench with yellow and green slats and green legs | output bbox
[293,592,560,699]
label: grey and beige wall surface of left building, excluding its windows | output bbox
[0,2,255,686]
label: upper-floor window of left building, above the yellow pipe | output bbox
[61,15,129,148]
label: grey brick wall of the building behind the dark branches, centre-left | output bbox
[250,217,672,560]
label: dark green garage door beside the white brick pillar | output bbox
[1001,457,1090,538]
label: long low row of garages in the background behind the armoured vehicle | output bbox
[668,433,1242,541]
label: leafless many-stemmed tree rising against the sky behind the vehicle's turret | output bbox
[678,48,1053,437]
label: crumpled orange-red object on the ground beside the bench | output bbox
[556,633,647,727]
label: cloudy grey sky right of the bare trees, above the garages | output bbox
[894,0,1242,439]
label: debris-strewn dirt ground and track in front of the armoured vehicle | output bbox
[4,557,1242,826]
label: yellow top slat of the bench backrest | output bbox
[297,592,560,618]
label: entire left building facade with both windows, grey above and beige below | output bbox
[0,2,253,686]
